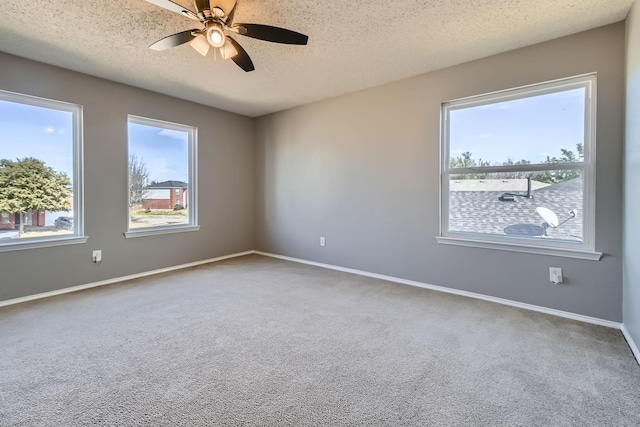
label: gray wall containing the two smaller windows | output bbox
[0,53,255,300]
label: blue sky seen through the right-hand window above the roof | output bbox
[449,88,585,165]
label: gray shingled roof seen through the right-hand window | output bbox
[449,178,583,241]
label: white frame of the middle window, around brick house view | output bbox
[124,114,200,239]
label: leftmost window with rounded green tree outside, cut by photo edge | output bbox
[0,91,87,251]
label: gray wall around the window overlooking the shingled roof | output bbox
[256,23,625,322]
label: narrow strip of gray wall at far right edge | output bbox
[622,1,640,352]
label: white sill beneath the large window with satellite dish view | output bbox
[436,236,602,261]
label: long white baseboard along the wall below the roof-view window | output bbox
[254,251,624,332]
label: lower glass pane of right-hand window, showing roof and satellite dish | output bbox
[449,170,584,242]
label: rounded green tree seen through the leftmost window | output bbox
[0,157,71,231]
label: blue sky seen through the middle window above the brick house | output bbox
[129,123,189,182]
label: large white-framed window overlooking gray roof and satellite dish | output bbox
[438,75,601,259]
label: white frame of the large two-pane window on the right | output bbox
[436,73,602,261]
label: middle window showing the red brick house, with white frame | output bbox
[125,116,199,237]
